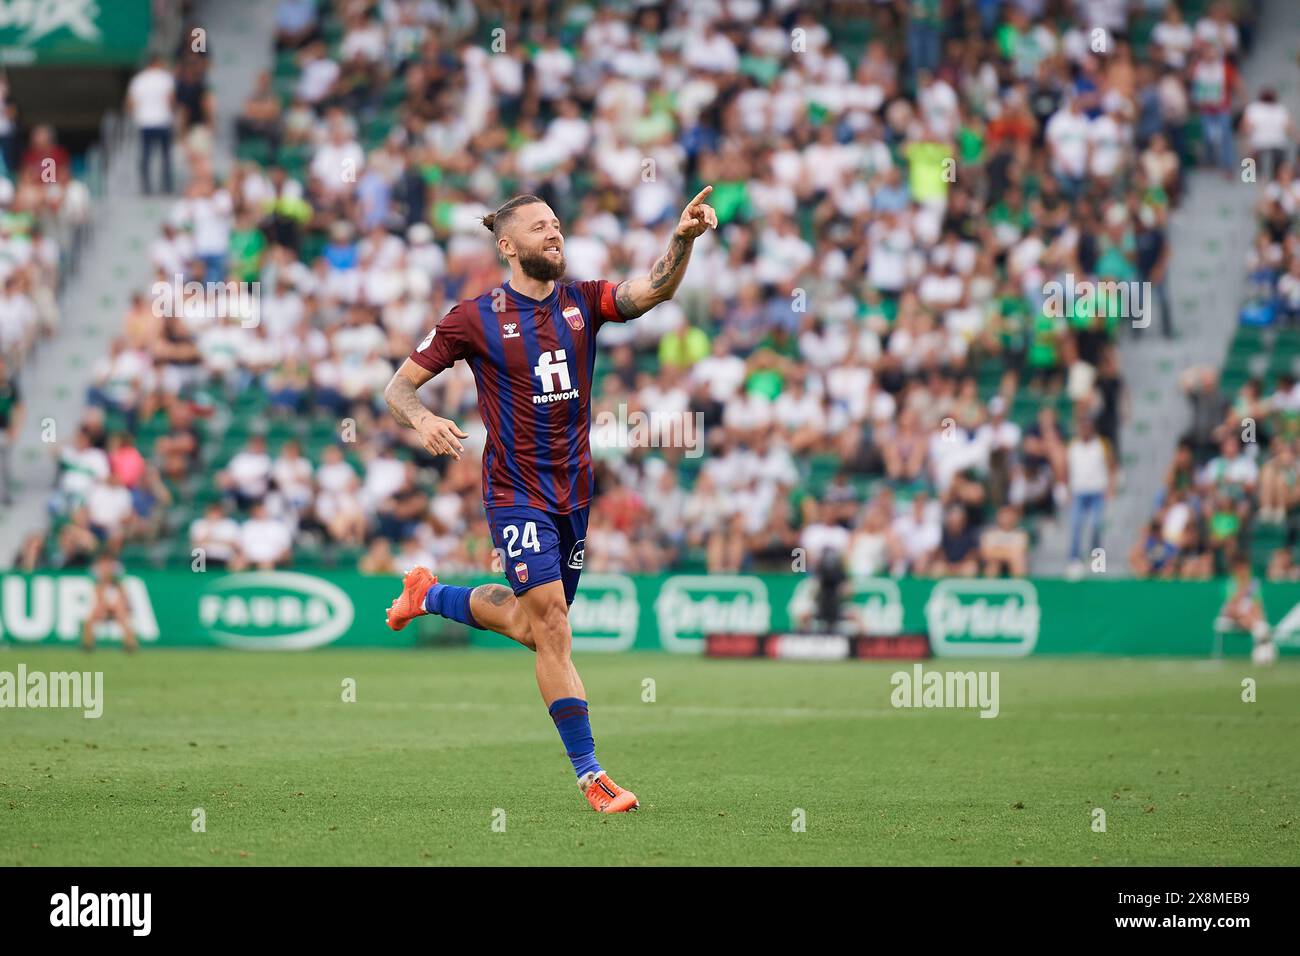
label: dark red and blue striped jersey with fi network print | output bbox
[411,280,624,514]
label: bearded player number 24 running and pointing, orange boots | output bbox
[385,186,718,813]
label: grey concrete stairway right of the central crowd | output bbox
[1032,0,1300,576]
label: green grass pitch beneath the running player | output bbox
[0,648,1300,866]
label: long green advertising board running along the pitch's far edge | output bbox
[0,571,1300,657]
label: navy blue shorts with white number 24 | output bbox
[488,506,588,604]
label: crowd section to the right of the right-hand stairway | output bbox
[1130,151,1300,580]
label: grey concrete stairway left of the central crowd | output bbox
[0,0,274,568]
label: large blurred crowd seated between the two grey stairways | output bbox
[25,0,1268,575]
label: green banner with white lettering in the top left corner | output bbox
[0,0,151,66]
